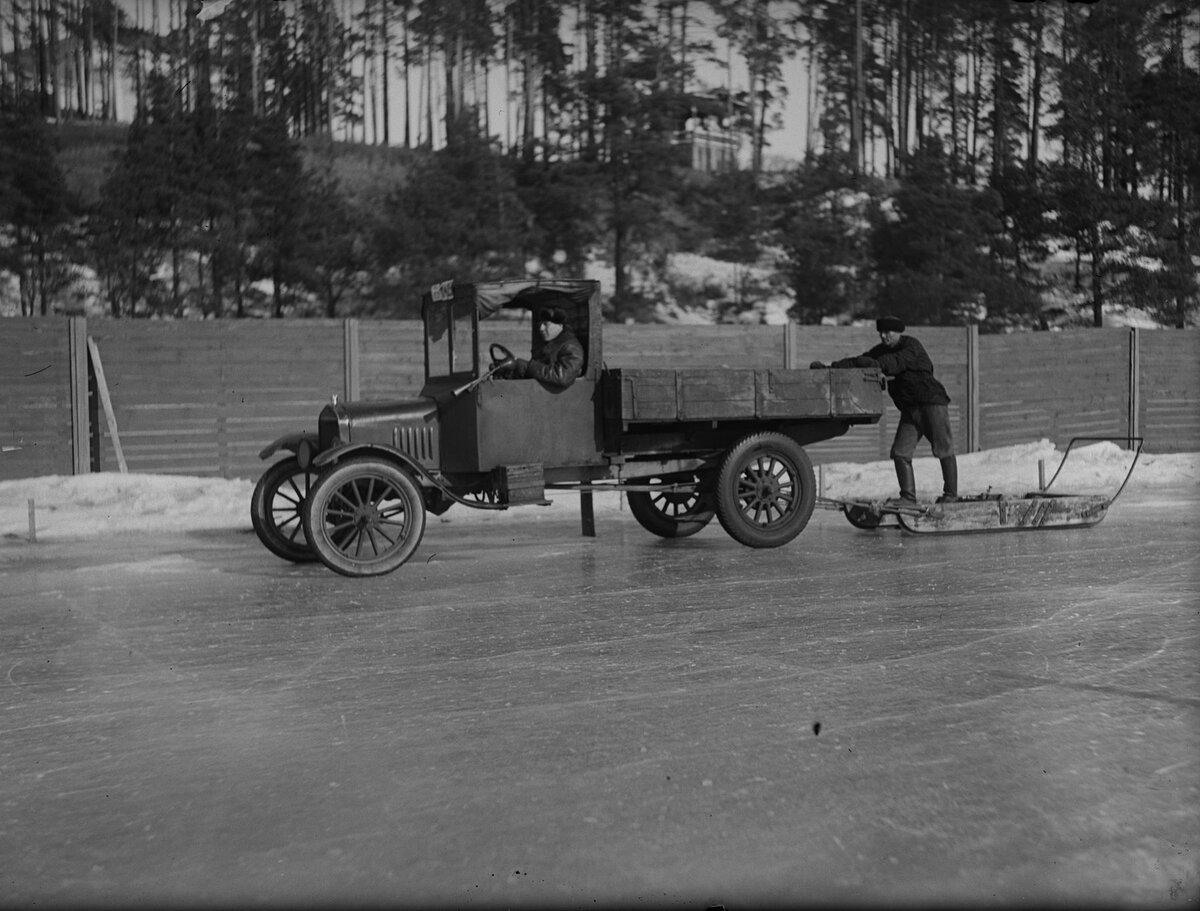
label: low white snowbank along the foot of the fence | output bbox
[0,439,1200,543]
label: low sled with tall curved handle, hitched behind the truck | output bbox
[817,437,1142,534]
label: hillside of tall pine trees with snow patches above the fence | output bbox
[0,0,1200,331]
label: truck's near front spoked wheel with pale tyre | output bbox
[304,457,425,576]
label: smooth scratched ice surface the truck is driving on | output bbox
[0,487,1200,909]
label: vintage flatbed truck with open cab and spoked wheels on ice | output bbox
[251,280,883,576]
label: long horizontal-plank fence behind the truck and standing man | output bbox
[0,318,1200,479]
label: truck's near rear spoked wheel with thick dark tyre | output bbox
[716,433,817,547]
